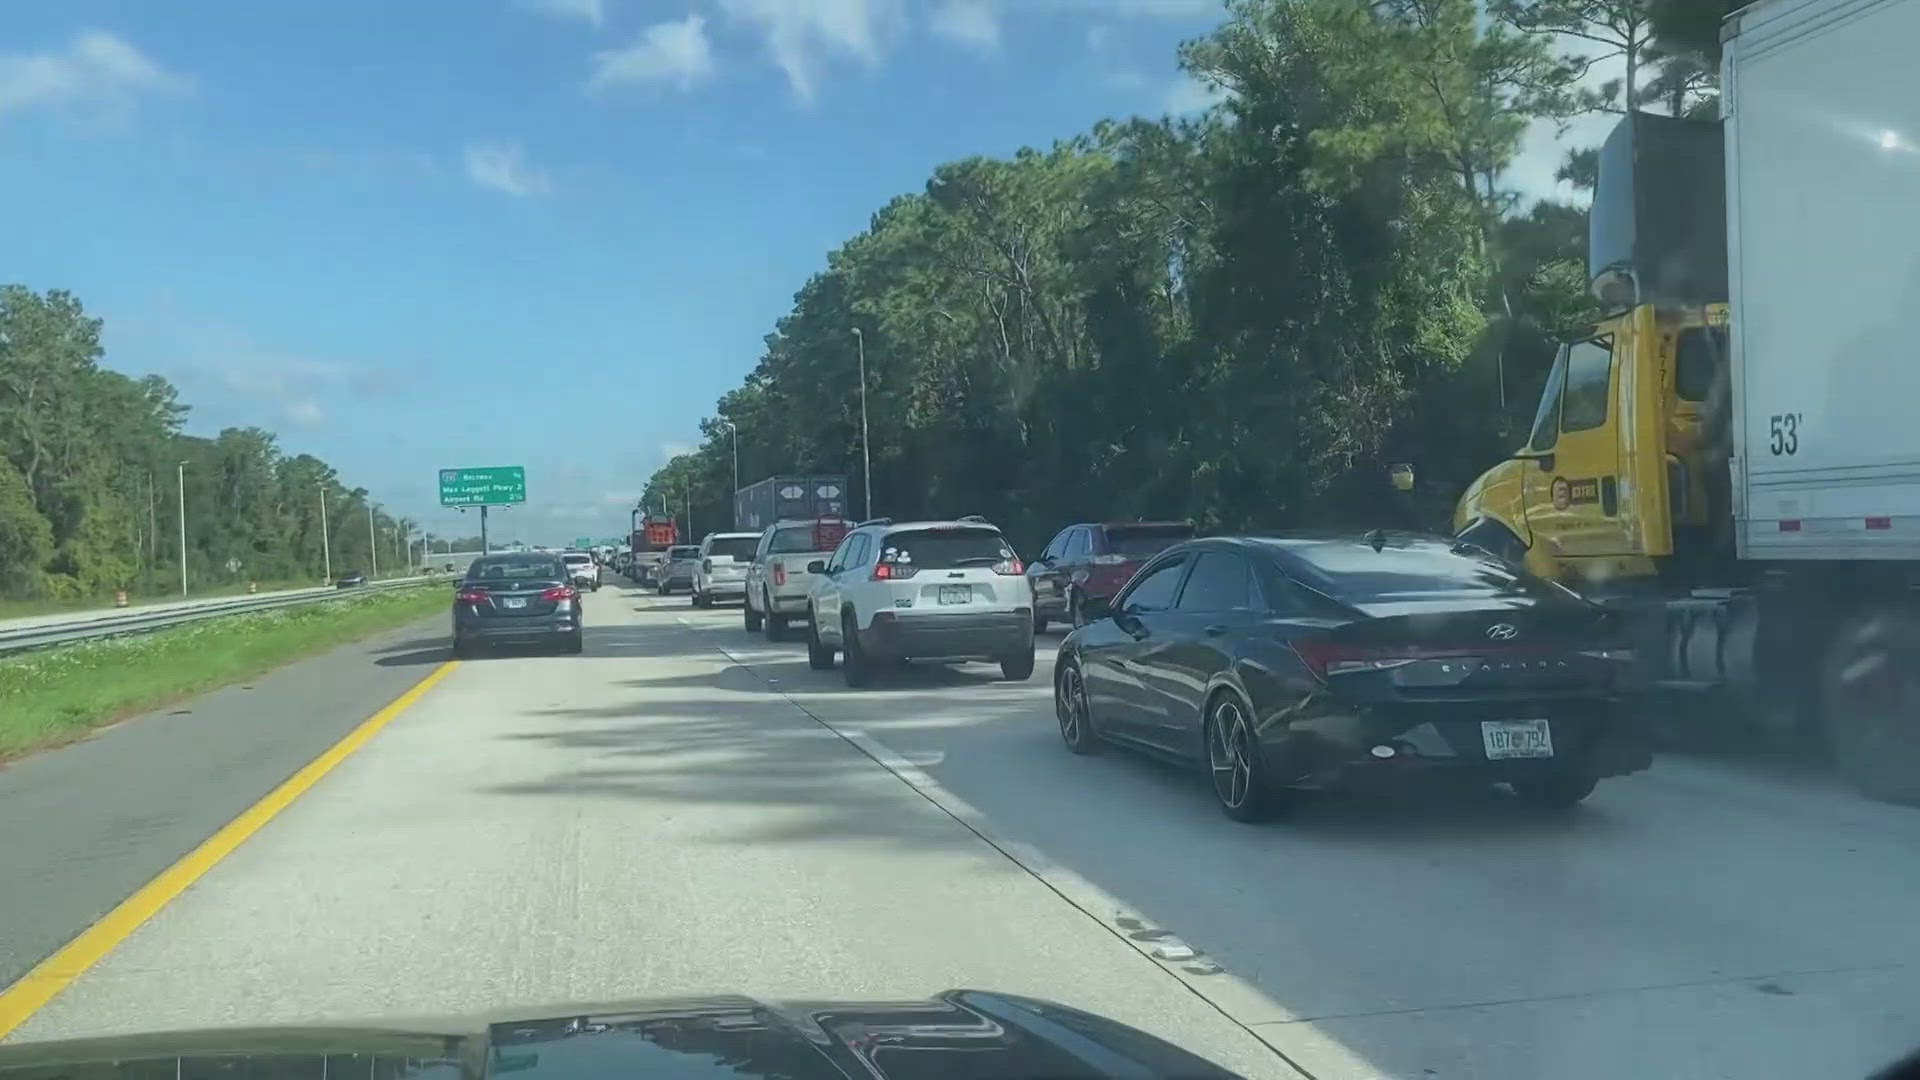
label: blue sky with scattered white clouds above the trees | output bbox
[0,0,1589,542]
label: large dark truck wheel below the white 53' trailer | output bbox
[1820,605,1920,803]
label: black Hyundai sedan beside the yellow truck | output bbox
[1054,532,1651,821]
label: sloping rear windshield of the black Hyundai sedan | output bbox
[1288,540,1572,605]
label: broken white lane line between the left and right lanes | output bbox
[674,617,1328,1080]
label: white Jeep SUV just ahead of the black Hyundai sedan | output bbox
[806,517,1033,686]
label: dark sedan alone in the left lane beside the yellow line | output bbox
[453,552,586,657]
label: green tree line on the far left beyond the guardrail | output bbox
[0,284,413,598]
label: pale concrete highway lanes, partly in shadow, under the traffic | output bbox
[0,588,1920,1080]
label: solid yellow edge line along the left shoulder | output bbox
[0,659,461,1038]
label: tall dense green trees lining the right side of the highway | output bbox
[643,0,1734,553]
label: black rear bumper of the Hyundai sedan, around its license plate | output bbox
[1261,701,1653,788]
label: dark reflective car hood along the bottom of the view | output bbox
[0,990,1233,1080]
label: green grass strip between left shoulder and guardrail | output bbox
[0,584,447,761]
